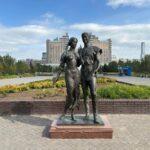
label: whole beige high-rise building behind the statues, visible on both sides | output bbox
[42,33,112,64]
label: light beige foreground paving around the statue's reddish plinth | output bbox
[0,115,150,150]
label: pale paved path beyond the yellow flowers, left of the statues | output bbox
[0,76,52,86]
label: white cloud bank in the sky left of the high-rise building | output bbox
[0,13,64,58]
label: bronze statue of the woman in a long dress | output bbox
[53,37,80,121]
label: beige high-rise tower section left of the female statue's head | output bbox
[44,33,69,64]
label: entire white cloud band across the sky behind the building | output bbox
[0,13,150,59]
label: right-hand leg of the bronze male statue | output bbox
[89,77,97,123]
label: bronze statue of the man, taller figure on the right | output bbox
[78,32,102,123]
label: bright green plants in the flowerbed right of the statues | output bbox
[97,83,150,99]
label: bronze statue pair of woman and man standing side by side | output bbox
[53,32,102,124]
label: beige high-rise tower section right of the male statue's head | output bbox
[90,34,112,64]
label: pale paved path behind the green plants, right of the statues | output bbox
[106,75,150,86]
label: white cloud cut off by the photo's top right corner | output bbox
[107,0,150,8]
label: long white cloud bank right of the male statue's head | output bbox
[70,23,150,58]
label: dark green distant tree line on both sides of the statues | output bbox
[0,55,150,75]
